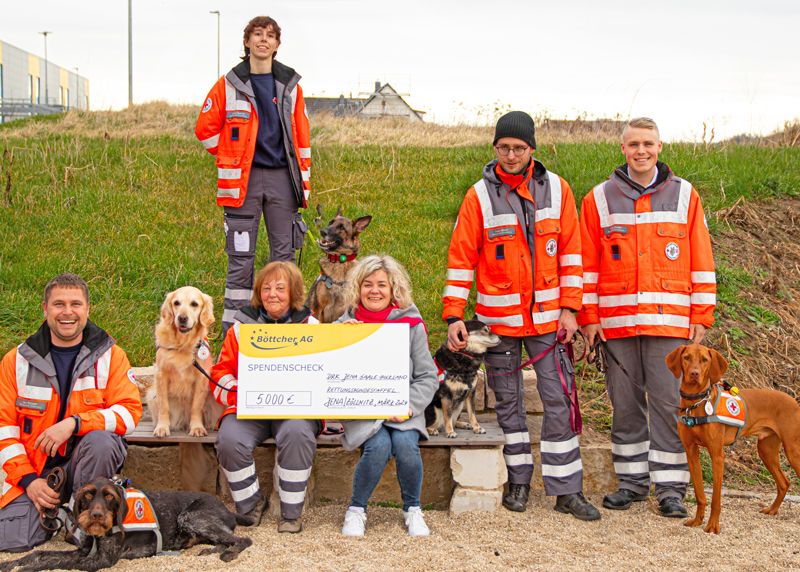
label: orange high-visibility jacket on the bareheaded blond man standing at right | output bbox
[578,163,717,339]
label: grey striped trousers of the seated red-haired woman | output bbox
[216,414,320,520]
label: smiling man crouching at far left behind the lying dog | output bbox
[0,274,142,552]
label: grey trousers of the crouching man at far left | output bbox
[0,431,127,552]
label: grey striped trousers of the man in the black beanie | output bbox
[486,332,583,496]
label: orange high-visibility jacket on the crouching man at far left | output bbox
[0,322,142,507]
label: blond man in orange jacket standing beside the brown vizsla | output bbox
[578,117,716,518]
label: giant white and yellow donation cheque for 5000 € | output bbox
[236,324,410,419]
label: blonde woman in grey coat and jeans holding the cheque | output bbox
[337,255,437,536]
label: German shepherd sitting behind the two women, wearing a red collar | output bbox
[306,205,372,324]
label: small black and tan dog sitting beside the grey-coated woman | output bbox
[425,320,500,439]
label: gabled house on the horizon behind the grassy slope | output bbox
[305,81,424,122]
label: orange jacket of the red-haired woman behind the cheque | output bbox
[210,306,319,423]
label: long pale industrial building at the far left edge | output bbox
[0,41,89,123]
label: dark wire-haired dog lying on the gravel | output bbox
[0,478,253,570]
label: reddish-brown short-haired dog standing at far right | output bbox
[666,344,800,534]
